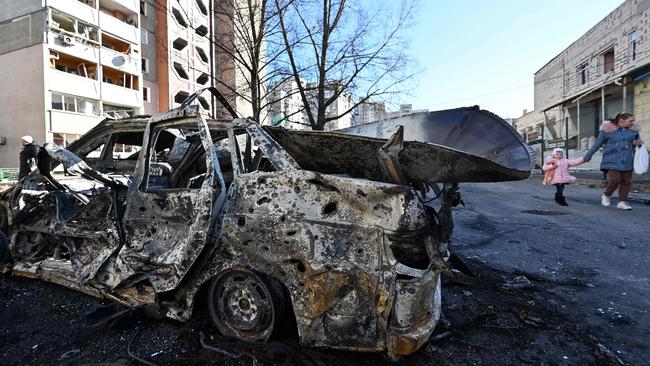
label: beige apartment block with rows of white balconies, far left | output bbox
[0,0,143,168]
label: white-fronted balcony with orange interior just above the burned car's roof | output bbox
[102,67,142,108]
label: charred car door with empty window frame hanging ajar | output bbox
[118,115,225,292]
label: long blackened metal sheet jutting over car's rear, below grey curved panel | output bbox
[265,127,530,185]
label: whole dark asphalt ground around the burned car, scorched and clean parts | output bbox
[0,180,650,366]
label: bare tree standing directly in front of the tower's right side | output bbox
[154,0,302,122]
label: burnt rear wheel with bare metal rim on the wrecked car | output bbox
[208,268,282,342]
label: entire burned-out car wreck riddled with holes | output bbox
[0,91,530,357]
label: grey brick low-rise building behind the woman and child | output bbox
[528,0,650,166]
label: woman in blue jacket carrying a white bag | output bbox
[584,112,643,210]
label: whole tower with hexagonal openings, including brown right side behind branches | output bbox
[140,0,252,117]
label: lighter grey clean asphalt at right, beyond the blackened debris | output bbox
[454,179,650,364]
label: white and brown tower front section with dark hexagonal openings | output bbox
[140,0,215,115]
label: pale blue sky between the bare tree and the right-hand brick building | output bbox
[404,0,623,118]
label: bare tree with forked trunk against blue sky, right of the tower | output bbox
[274,0,416,130]
